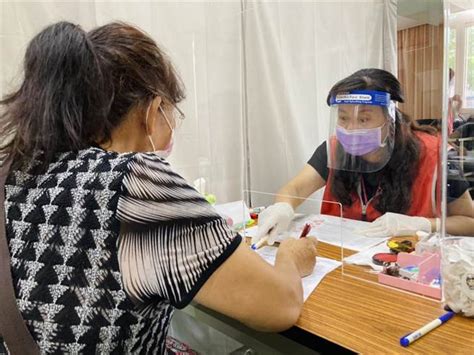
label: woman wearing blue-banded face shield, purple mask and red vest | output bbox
[253,69,474,248]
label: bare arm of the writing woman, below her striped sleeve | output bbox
[194,238,315,331]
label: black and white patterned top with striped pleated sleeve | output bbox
[5,148,240,354]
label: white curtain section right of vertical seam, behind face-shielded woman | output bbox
[245,0,396,200]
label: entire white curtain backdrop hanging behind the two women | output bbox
[0,0,396,202]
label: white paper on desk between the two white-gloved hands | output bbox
[270,214,387,251]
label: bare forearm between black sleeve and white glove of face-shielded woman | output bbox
[275,164,326,209]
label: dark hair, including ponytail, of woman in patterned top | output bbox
[0,22,184,171]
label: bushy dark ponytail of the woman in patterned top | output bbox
[0,22,113,170]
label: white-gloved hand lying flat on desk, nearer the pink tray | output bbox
[354,212,431,237]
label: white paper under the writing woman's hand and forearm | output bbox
[257,246,341,301]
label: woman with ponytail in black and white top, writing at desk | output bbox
[0,22,316,354]
